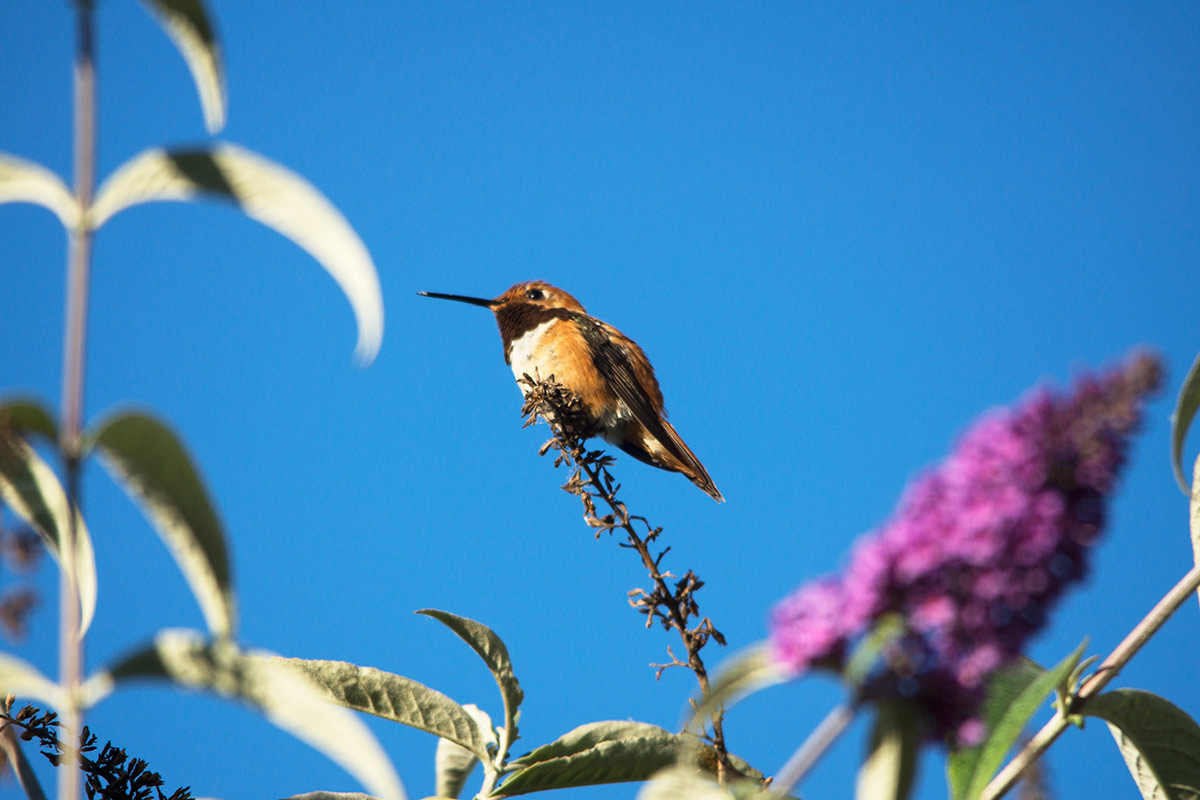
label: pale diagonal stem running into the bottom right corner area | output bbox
[980,565,1200,800]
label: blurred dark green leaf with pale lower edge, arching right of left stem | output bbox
[88,411,236,636]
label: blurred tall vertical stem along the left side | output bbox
[59,6,96,800]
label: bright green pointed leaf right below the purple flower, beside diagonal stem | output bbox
[947,640,1087,800]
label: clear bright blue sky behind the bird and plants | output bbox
[0,0,1200,799]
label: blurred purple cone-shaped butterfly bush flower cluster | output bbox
[770,355,1162,744]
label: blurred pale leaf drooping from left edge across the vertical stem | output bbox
[0,426,96,636]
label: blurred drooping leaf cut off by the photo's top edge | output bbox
[142,0,226,133]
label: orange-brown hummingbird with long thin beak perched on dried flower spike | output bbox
[418,281,725,503]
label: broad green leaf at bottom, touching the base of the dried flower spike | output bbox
[497,722,694,795]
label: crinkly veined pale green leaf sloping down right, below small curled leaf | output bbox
[278,658,488,759]
